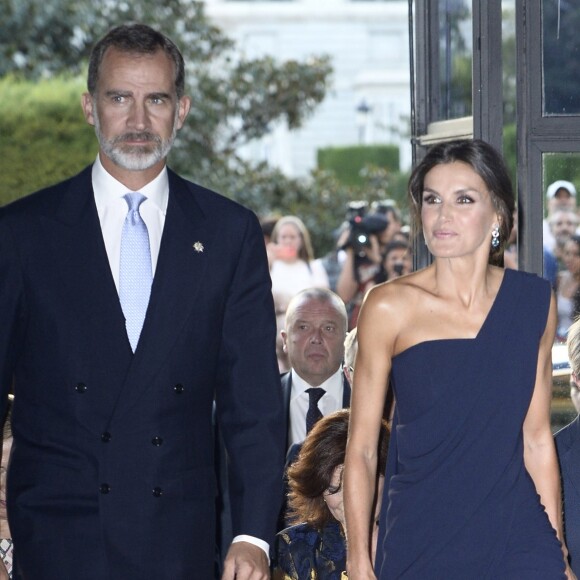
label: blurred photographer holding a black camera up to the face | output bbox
[336,201,390,330]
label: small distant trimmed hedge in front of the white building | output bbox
[317,145,399,186]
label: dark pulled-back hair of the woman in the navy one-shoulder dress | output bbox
[409,139,515,263]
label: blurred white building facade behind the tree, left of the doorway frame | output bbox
[205,0,411,177]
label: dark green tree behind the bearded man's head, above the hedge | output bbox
[0,0,332,176]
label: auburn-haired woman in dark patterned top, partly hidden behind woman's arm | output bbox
[274,409,389,580]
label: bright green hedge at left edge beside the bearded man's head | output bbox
[0,78,98,205]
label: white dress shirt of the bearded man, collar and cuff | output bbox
[92,156,270,556]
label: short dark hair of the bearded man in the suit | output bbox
[87,24,185,99]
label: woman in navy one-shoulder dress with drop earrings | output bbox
[344,140,574,580]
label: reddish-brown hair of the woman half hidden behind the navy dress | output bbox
[288,409,389,529]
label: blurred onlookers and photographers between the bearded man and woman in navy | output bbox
[261,199,413,358]
